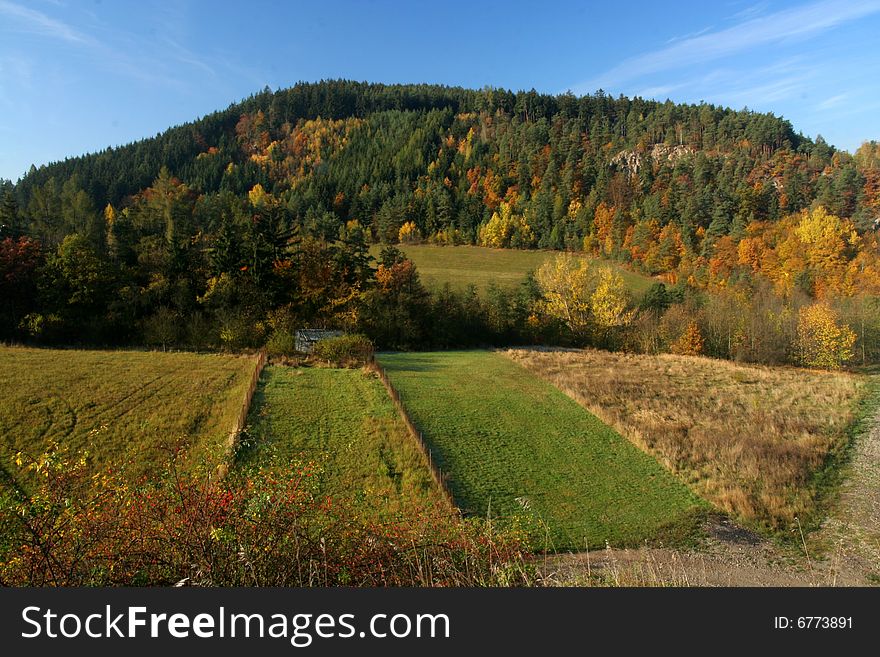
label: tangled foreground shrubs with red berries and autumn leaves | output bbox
[0,444,534,586]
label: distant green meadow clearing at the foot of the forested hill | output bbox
[372,245,653,297]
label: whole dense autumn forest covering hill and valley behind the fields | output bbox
[0,81,880,366]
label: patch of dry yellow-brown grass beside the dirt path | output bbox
[506,349,866,530]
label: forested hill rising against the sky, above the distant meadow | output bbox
[4,81,878,250]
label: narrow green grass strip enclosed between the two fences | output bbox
[238,366,450,516]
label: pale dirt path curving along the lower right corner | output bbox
[541,392,880,586]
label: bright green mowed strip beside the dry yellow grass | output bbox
[379,351,703,549]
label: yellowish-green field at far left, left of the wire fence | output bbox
[0,347,255,484]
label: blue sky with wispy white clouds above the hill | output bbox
[0,0,880,180]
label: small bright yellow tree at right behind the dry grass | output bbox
[797,303,856,369]
